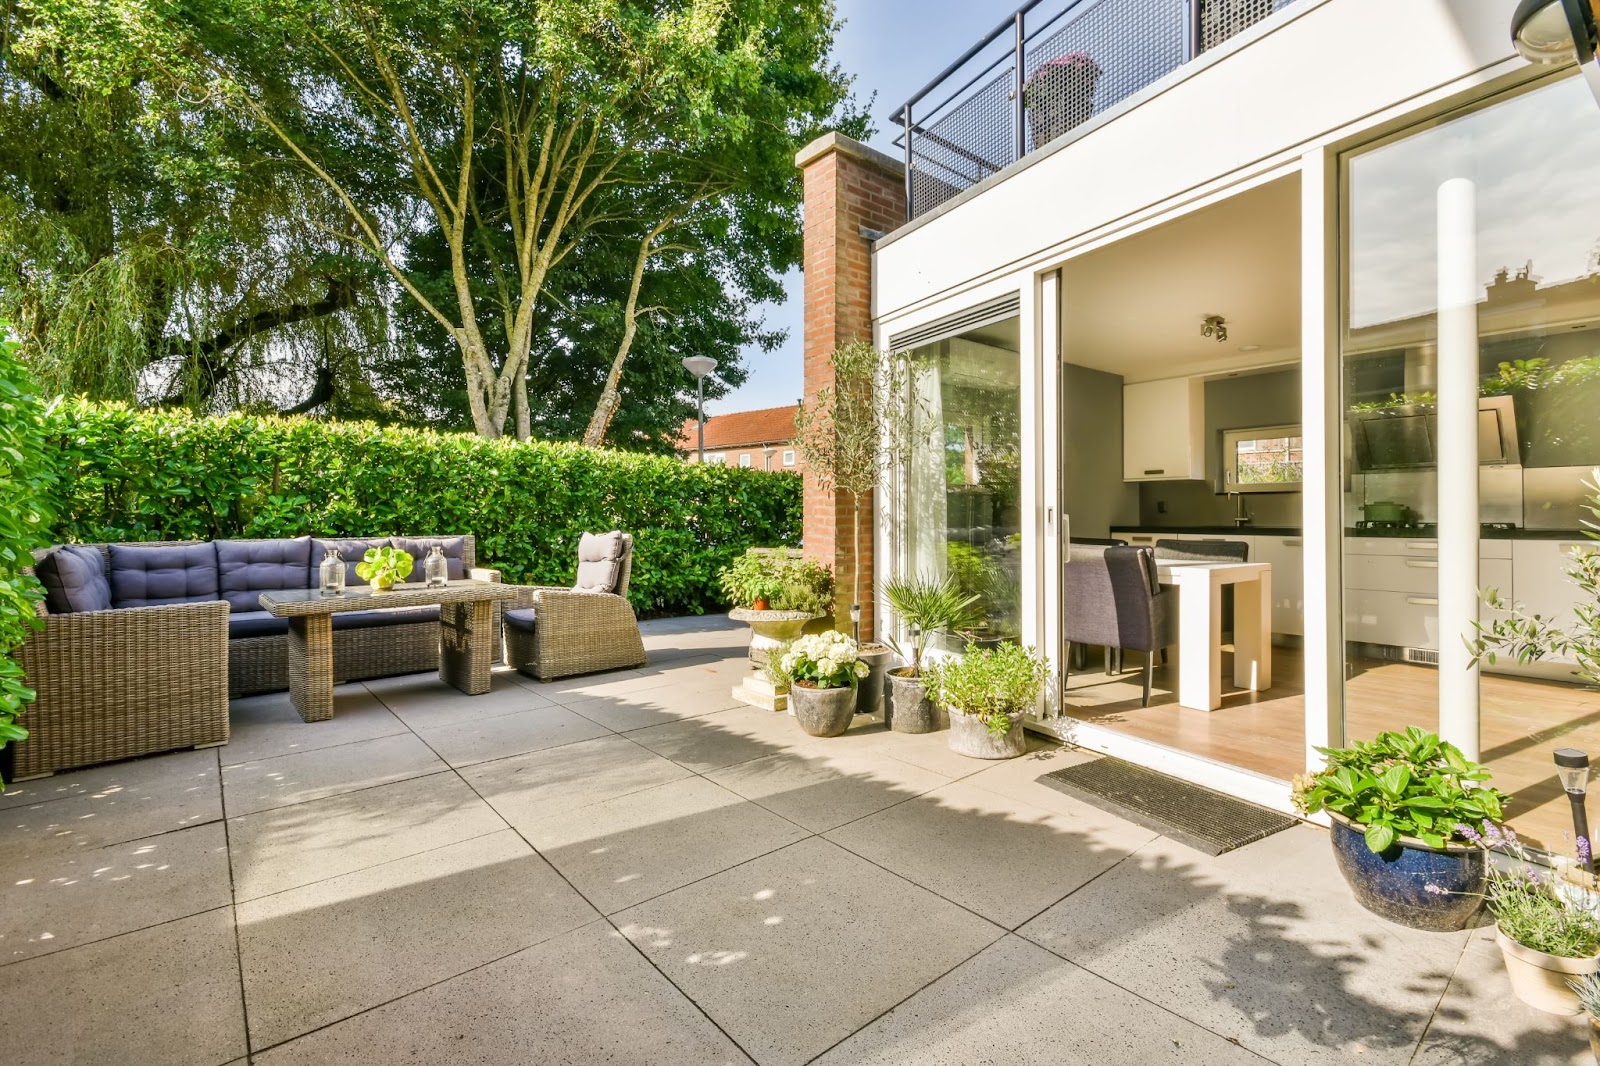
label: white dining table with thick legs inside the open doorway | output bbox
[1155,559,1272,711]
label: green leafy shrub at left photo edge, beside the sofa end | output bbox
[0,322,56,771]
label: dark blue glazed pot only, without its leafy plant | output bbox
[1328,812,1488,933]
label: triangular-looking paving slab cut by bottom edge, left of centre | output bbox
[254,922,750,1066]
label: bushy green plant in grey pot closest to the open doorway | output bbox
[928,640,1045,759]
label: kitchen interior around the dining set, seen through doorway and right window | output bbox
[1061,168,1600,845]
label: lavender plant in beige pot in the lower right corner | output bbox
[1459,823,1600,1016]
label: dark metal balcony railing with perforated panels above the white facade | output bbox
[891,0,1294,218]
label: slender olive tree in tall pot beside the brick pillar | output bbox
[795,344,912,714]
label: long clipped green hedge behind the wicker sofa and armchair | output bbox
[50,402,800,615]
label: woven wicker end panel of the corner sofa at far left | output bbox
[13,549,229,779]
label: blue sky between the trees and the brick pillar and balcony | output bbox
[706,0,1016,415]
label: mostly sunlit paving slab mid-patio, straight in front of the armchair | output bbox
[461,736,691,828]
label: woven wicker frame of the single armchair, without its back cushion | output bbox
[504,535,645,680]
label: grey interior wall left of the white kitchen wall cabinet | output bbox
[1061,363,1139,536]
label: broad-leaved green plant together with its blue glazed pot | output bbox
[1294,727,1507,932]
